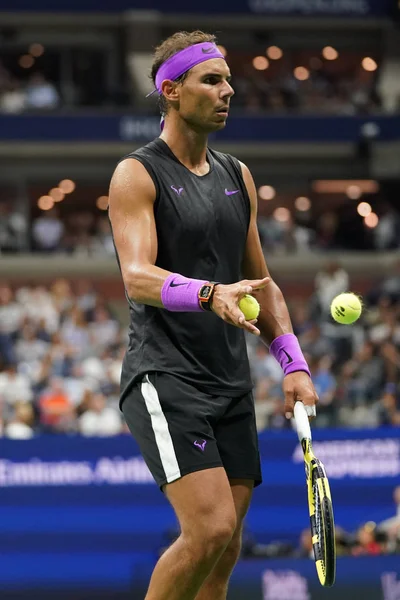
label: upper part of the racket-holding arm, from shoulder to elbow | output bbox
[240,163,269,279]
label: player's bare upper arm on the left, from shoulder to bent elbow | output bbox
[109,159,157,278]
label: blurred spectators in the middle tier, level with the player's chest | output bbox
[0,198,400,256]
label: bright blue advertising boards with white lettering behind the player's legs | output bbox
[0,429,400,600]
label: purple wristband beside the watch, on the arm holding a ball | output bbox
[161,273,207,312]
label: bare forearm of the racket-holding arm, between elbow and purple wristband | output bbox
[254,281,293,346]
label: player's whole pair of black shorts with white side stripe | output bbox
[121,372,262,487]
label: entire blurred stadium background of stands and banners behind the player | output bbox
[0,0,400,600]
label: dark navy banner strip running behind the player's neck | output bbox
[0,114,400,143]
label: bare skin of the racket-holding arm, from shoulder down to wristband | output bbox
[240,163,293,346]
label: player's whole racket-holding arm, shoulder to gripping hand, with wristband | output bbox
[241,163,318,418]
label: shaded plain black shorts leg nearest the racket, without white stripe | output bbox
[214,393,262,486]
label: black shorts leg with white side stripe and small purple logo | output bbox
[122,373,227,487]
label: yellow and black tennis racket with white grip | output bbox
[294,402,336,587]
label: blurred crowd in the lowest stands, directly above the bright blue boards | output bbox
[0,261,400,437]
